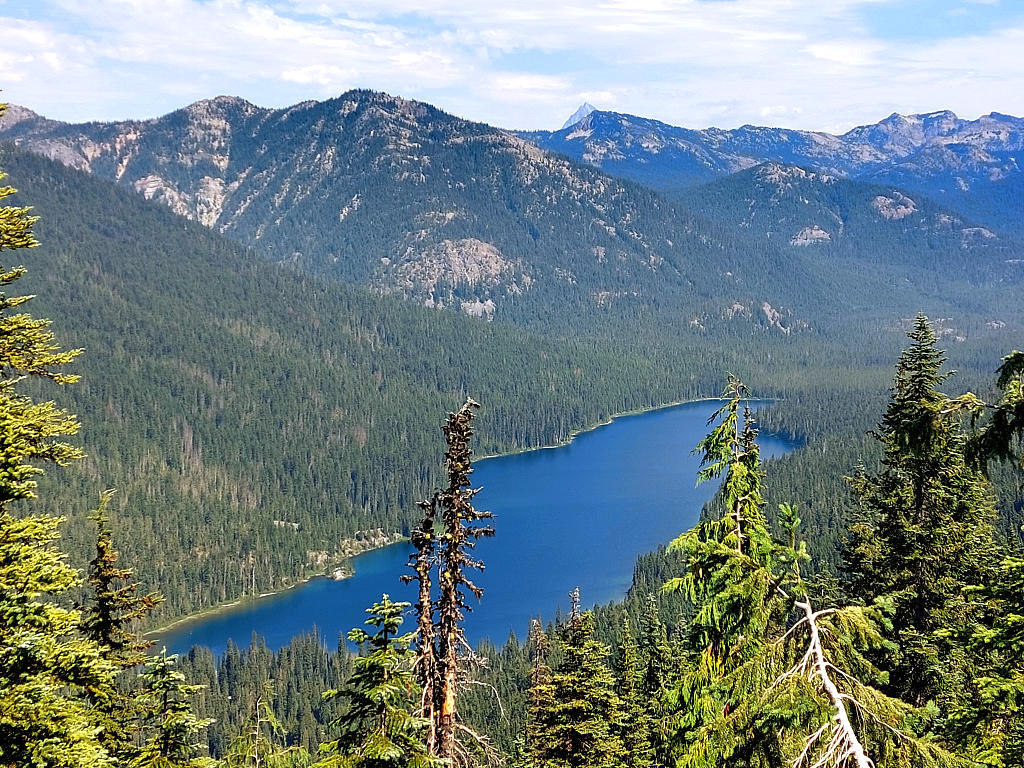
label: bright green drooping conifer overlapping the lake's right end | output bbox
[666,377,793,768]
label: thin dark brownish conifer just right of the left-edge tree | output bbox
[82,490,163,763]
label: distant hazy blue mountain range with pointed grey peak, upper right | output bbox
[521,108,1024,231]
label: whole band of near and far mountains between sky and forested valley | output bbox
[0,91,1024,332]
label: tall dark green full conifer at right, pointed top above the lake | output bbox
[844,315,998,706]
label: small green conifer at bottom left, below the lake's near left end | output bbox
[131,651,213,768]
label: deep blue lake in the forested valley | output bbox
[157,401,795,653]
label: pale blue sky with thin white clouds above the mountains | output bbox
[0,0,1024,133]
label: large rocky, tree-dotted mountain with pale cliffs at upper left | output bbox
[0,91,737,317]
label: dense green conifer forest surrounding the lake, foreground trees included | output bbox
[0,97,1024,768]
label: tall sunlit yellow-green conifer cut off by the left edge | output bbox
[0,105,113,768]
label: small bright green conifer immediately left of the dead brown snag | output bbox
[316,595,442,768]
